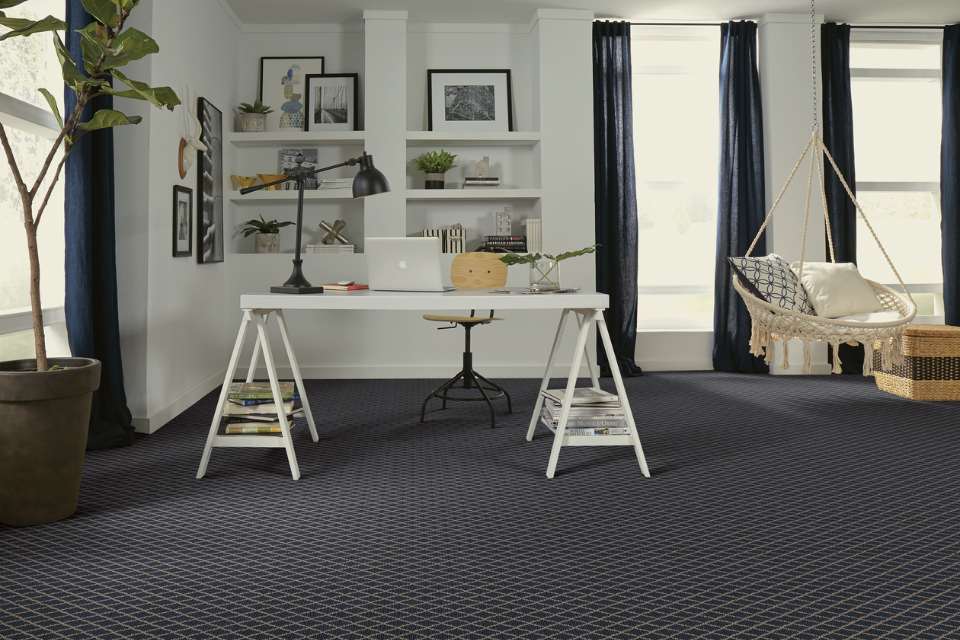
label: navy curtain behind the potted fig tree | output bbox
[64,0,133,449]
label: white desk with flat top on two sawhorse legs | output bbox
[197,290,650,480]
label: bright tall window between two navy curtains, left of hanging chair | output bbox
[632,26,720,331]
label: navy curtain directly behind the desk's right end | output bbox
[593,22,641,376]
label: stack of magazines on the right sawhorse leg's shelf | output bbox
[540,388,630,436]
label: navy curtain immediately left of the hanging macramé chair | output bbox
[713,22,767,373]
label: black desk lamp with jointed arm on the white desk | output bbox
[240,153,390,293]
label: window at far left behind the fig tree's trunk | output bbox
[0,0,65,360]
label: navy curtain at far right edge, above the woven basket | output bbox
[940,24,960,326]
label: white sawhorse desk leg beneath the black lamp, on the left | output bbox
[197,309,320,480]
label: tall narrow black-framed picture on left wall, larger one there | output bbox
[197,98,223,264]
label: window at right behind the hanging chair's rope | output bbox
[850,30,943,321]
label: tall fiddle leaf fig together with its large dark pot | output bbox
[0,0,180,526]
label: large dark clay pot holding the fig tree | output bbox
[0,358,100,526]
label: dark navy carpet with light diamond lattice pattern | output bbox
[0,374,960,640]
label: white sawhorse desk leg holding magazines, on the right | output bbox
[527,309,650,478]
